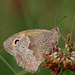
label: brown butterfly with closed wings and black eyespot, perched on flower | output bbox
[3,27,60,73]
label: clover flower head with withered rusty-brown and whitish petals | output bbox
[42,34,75,75]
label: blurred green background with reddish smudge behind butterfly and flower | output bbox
[0,0,75,75]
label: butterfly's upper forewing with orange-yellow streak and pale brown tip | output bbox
[3,29,49,54]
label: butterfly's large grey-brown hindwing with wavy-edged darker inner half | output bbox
[4,30,58,73]
